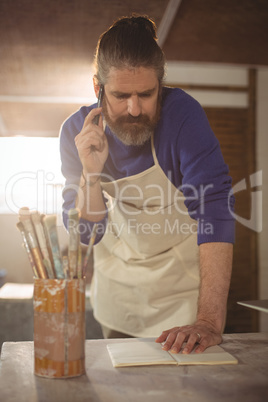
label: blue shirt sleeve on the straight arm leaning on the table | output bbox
[174,96,235,244]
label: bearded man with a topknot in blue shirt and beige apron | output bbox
[61,16,234,353]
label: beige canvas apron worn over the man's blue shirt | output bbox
[91,139,199,337]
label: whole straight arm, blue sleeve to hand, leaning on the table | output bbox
[157,90,235,352]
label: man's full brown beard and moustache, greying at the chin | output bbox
[102,96,161,146]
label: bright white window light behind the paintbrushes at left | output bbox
[0,137,64,214]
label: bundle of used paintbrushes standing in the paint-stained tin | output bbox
[17,207,97,279]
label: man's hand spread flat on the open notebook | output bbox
[156,322,222,354]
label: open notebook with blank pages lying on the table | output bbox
[107,341,238,367]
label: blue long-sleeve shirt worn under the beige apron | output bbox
[60,87,235,244]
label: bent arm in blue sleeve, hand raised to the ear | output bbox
[60,107,108,244]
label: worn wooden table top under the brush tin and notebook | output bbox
[0,333,268,402]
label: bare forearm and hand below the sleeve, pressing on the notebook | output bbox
[156,243,233,353]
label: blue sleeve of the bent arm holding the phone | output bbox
[60,107,107,244]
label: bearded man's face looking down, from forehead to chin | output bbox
[99,67,160,145]
